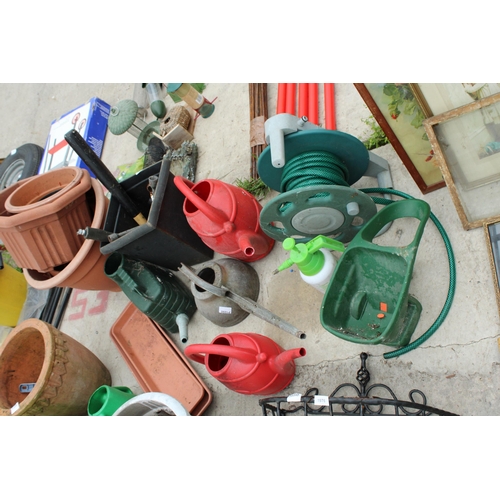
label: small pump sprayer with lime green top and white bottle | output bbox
[273,235,345,293]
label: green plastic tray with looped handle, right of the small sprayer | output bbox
[320,199,430,347]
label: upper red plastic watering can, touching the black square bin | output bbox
[174,176,274,262]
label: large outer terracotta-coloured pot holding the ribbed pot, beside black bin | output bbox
[23,179,121,292]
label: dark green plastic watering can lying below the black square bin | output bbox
[104,253,196,342]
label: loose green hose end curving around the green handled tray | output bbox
[360,188,456,359]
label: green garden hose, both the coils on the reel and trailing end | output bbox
[274,152,456,359]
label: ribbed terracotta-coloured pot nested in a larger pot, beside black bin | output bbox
[0,167,92,272]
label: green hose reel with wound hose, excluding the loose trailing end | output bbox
[257,124,392,243]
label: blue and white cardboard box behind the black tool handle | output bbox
[38,97,111,177]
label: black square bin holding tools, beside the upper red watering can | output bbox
[101,162,214,270]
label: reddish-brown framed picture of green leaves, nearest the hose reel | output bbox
[354,83,446,194]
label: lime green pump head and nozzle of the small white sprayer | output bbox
[274,235,345,276]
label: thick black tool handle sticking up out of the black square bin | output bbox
[64,129,147,225]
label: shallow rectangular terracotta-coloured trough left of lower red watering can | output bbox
[110,302,212,415]
